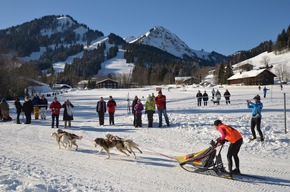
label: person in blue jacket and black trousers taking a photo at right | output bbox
[247,95,264,141]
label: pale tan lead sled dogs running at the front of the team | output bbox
[51,129,83,150]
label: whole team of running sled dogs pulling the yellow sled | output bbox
[51,129,142,159]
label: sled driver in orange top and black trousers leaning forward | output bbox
[214,120,243,178]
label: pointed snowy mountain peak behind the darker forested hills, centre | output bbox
[129,26,227,61]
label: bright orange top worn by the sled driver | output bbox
[218,123,242,143]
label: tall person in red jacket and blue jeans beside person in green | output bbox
[155,91,170,127]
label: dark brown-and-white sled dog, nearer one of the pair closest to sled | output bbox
[95,138,131,159]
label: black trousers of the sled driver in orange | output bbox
[227,138,243,173]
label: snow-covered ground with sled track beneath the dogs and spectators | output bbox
[0,86,290,192]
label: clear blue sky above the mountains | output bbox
[0,0,290,55]
